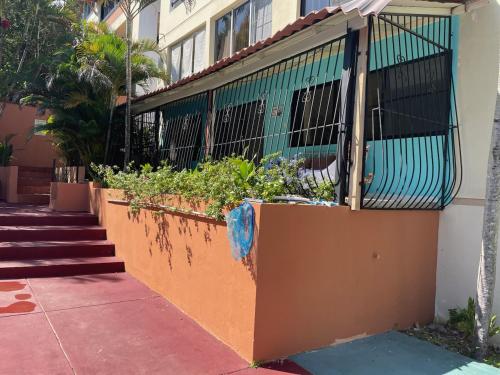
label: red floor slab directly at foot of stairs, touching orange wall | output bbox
[29,273,158,311]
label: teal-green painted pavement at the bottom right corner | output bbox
[291,332,500,375]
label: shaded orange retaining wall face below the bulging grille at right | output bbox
[254,204,439,359]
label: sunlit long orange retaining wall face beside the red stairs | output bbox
[90,188,259,360]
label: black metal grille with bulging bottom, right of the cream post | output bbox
[362,14,461,209]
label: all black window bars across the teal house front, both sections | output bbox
[132,14,461,209]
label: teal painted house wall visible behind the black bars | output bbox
[157,17,459,207]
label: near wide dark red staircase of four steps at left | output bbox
[0,210,125,279]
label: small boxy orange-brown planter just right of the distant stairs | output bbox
[49,182,89,212]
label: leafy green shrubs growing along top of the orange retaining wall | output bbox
[92,154,334,219]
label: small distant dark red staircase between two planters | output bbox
[17,167,53,205]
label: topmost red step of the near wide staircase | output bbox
[0,209,99,226]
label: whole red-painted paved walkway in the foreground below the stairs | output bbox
[0,273,307,375]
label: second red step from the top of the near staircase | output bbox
[0,225,106,241]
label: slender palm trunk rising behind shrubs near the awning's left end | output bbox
[103,0,156,168]
